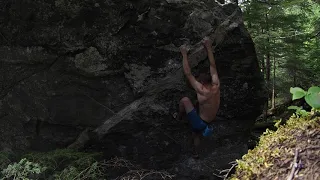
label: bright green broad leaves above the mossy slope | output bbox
[290,86,320,109]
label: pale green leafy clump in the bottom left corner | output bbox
[1,158,46,180]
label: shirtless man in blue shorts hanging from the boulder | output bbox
[177,37,220,158]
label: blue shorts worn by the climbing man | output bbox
[187,109,213,136]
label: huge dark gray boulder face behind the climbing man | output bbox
[0,0,265,179]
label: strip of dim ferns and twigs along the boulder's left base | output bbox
[0,149,175,180]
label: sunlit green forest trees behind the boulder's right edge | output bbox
[225,0,320,109]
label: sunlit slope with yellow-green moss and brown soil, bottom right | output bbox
[231,116,320,180]
